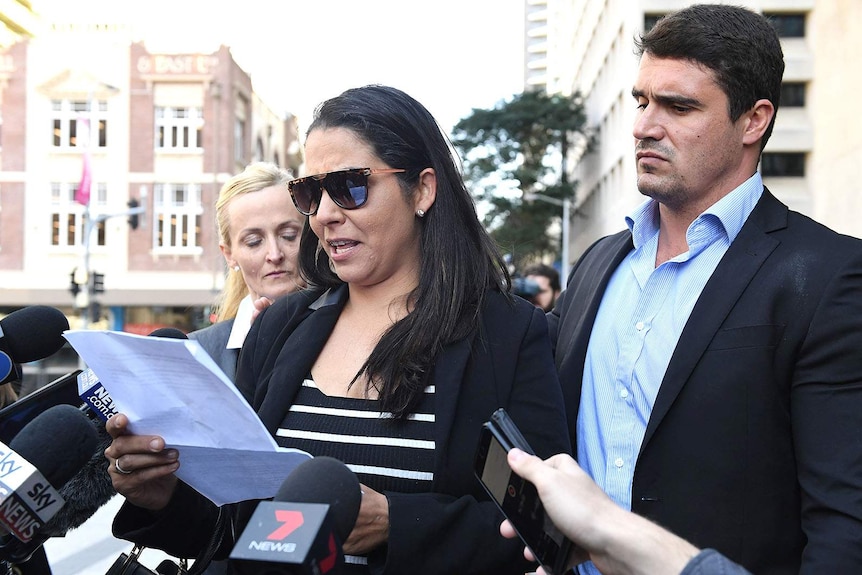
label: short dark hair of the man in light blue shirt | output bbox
[635,4,784,151]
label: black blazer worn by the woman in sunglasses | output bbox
[114,288,571,575]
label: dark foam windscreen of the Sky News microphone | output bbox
[9,405,99,489]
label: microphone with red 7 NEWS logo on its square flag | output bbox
[230,457,362,575]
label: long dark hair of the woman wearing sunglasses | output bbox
[299,85,510,418]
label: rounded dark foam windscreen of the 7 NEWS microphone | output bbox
[273,456,362,541]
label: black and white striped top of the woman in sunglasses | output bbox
[276,377,435,573]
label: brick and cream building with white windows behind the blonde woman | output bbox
[0,7,301,382]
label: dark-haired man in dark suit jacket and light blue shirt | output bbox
[549,5,862,575]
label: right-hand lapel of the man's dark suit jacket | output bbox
[641,188,787,452]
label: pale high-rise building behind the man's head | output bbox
[524,0,862,259]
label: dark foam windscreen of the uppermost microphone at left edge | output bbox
[0,305,69,363]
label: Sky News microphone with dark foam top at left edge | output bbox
[0,405,98,552]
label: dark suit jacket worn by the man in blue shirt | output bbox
[549,190,862,575]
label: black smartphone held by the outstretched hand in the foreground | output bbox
[474,409,571,575]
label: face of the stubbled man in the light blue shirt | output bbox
[632,53,752,215]
